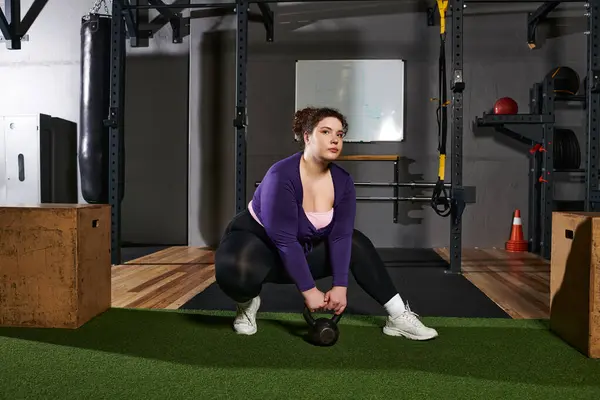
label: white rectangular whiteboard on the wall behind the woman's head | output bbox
[296,60,405,142]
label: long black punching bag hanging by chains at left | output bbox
[78,14,111,204]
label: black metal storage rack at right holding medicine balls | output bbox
[476,0,600,259]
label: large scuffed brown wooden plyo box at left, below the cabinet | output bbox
[0,204,111,328]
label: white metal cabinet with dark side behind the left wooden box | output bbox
[0,114,78,205]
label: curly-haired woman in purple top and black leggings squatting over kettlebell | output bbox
[215,107,438,340]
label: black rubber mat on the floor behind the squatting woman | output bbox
[180,249,510,318]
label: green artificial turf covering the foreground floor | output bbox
[0,309,600,400]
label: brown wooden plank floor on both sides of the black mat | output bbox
[112,247,550,319]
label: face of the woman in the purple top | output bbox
[304,117,345,161]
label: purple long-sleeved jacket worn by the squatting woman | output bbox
[252,152,356,292]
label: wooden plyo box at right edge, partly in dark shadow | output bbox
[550,212,600,358]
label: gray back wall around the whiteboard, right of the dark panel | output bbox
[189,1,585,247]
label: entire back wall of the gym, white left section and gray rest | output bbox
[0,0,585,247]
